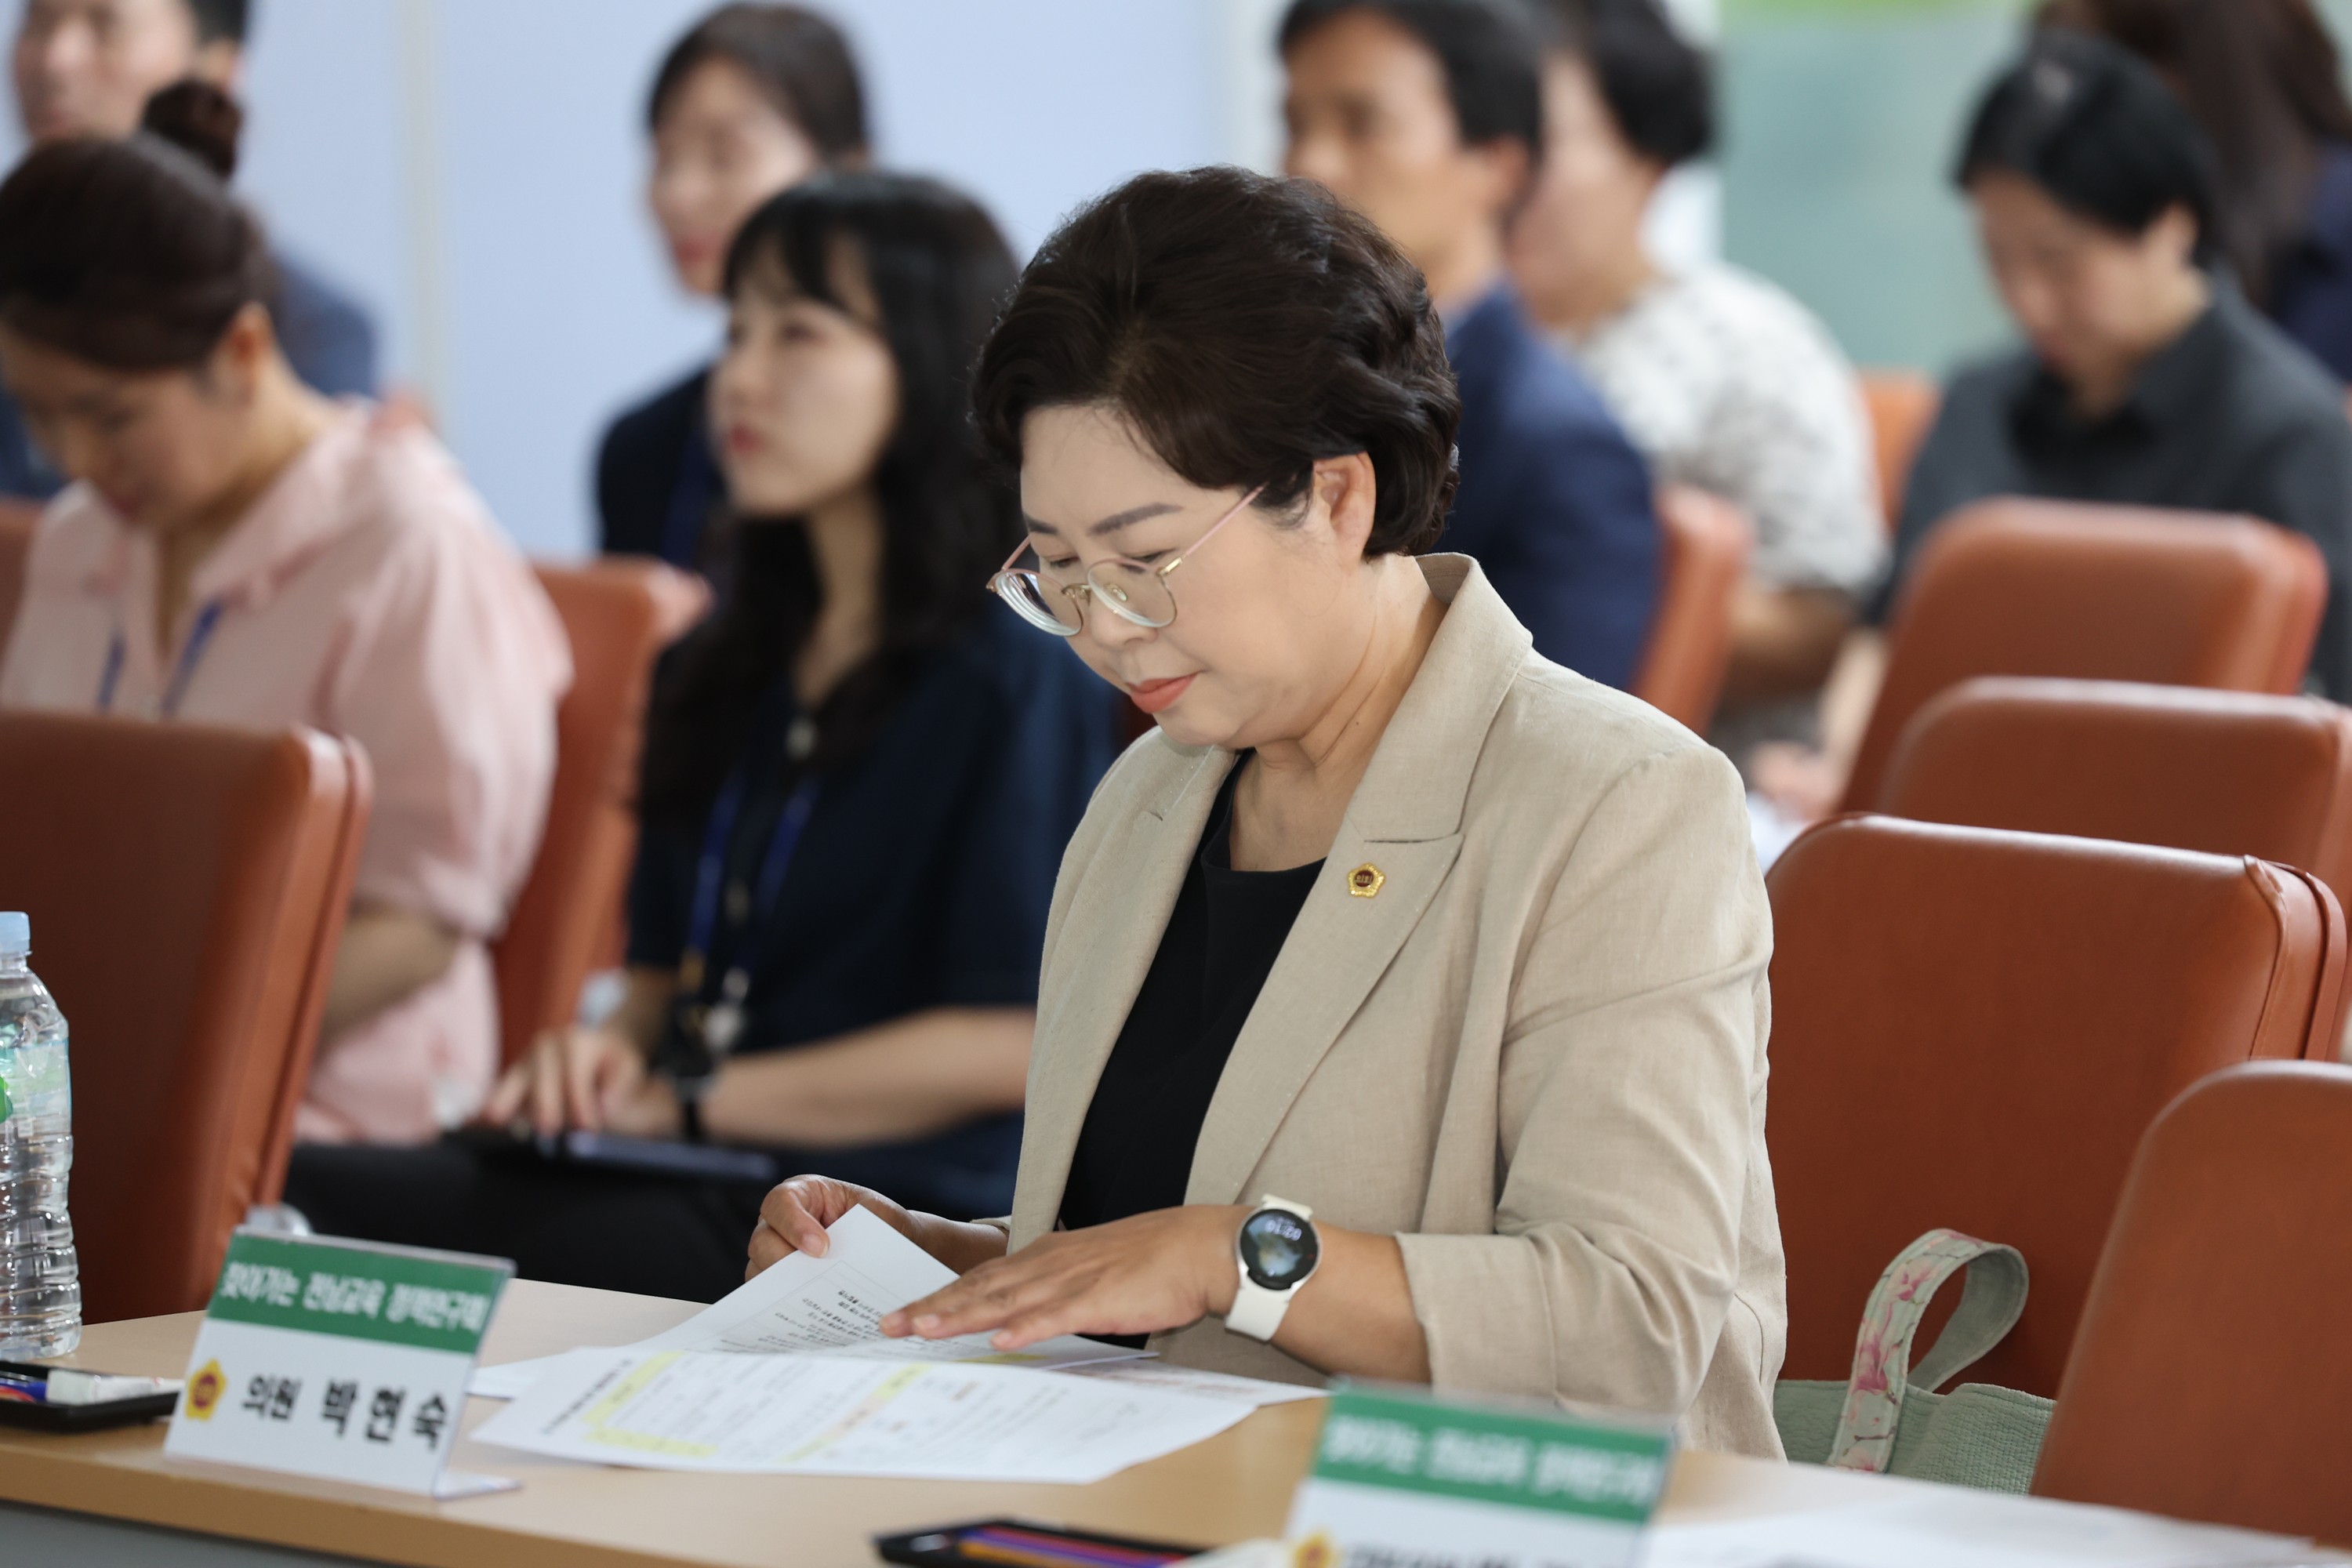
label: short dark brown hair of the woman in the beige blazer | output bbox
[974,169,1461,555]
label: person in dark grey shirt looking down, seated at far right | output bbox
[1752,31,2352,818]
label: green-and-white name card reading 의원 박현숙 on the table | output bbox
[162,1229,515,1497]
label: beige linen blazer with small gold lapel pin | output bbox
[1011,555,1788,1457]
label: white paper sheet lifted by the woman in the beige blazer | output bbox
[466,1208,1143,1399]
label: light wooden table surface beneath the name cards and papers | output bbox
[0,1281,1907,1568]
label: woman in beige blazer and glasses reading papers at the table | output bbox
[750,169,1785,1455]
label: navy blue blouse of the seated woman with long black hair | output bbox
[628,602,1117,1218]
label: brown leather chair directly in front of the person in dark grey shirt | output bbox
[1844,496,2328,811]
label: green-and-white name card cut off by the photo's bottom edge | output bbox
[1287,1387,1672,1568]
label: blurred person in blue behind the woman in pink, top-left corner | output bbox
[0,0,376,501]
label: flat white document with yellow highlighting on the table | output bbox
[473,1349,1249,1483]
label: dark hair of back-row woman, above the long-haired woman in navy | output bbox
[644,2,870,165]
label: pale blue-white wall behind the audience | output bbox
[0,0,1715,555]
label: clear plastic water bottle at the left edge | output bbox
[0,914,82,1356]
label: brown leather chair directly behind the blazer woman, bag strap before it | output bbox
[1766,815,2345,1396]
